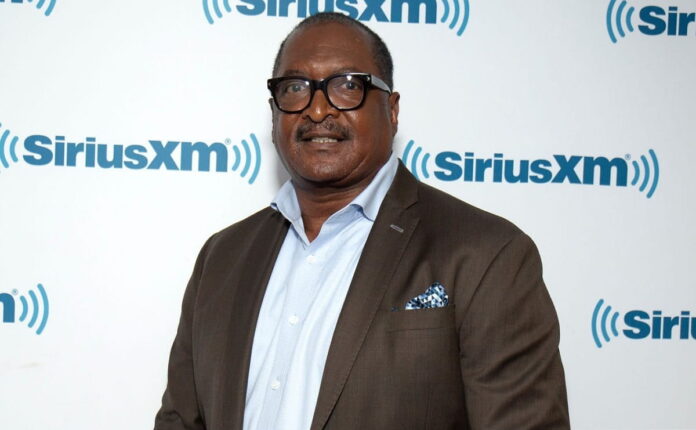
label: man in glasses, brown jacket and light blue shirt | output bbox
[155,14,569,430]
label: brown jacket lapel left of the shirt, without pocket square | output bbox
[215,211,289,430]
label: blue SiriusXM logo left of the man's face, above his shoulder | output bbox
[0,124,261,184]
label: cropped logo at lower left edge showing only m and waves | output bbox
[0,284,49,334]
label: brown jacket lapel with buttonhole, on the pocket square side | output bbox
[311,164,418,430]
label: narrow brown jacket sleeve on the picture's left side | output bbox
[155,240,211,430]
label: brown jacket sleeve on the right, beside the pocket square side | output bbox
[460,232,570,430]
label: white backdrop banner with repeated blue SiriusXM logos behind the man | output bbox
[0,0,696,430]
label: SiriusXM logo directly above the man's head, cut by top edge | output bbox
[203,0,469,36]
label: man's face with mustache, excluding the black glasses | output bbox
[271,23,399,188]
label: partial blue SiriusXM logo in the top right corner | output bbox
[606,0,696,43]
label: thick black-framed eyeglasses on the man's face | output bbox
[268,73,391,113]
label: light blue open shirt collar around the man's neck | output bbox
[271,151,399,224]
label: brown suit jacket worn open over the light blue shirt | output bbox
[155,162,569,430]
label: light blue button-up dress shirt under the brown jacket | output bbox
[244,153,398,430]
